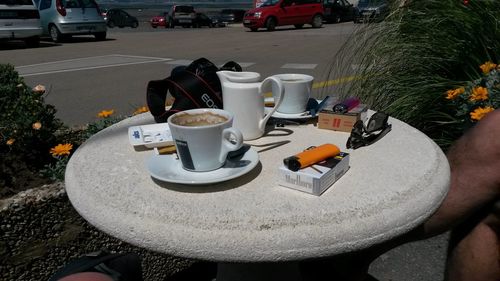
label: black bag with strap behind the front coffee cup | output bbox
[146,58,242,123]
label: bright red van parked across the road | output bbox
[243,0,323,31]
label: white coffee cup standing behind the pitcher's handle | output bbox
[271,73,314,114]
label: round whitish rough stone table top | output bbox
[66,113,449,262]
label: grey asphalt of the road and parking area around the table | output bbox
[0,19,447,281]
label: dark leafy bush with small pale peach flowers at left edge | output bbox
[0,64,63,194]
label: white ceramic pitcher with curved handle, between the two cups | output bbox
[217,70,284,140]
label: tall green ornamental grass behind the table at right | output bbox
[323,0,500,148]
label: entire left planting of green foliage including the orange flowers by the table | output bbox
[0,64,142,197]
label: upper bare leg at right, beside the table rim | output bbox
[423,110,500,237]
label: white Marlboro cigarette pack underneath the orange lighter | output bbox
[279,152,349,196]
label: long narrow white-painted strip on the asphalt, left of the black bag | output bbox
[16,54,172,77]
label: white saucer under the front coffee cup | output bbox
[146,148,259,184]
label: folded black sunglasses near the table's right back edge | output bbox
[346,112,392,149]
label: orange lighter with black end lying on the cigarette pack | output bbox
[283,143,340,172]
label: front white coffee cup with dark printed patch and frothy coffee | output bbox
[167,108,243,172]
